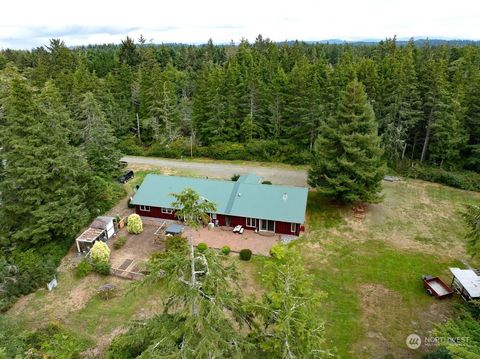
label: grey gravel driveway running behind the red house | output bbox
[122,156,307,187]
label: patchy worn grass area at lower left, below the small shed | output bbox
[7,270,163,349]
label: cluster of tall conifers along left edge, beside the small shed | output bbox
[0,60,125,312]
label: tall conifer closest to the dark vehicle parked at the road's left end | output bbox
[79,92,121,178]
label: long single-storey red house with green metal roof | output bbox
[132,174,308,235]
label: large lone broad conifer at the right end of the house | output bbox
[309,80,384,203]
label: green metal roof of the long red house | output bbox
[132,174,308,223]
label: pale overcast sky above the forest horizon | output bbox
[0,0,480,48]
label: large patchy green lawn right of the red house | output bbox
[252,181,480,358]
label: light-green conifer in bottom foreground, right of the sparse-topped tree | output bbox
[253,250,333,359]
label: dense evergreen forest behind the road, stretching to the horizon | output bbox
[0,36,480,172]
